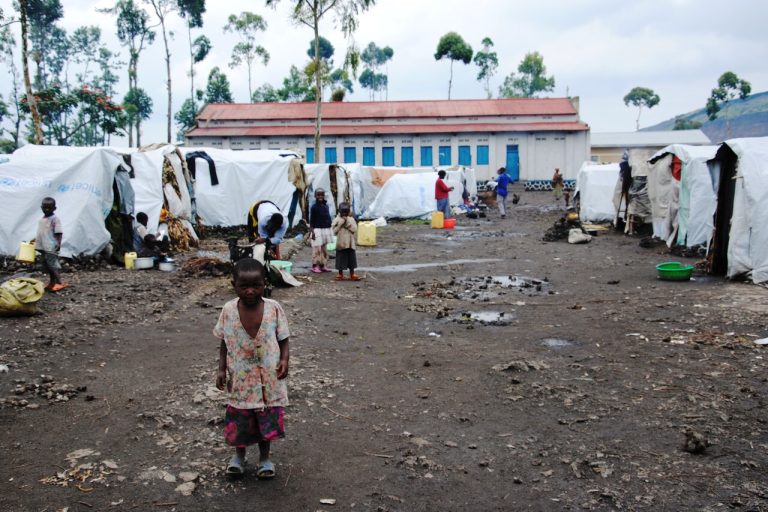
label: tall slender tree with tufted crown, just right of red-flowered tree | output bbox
[101,0,155,146]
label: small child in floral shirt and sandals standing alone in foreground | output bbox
[213,258,290,479]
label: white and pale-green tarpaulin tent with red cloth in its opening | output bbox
[648,144,717,247]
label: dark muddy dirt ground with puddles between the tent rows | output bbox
[0,188,768,512]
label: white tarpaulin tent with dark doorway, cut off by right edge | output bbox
[712,137,768,283]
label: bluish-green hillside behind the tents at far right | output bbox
[640,92,768,142]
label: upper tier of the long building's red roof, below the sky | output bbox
[198,98,578,121]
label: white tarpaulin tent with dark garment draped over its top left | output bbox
[180,147,300,226]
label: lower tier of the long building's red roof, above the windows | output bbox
[187,121,589,137]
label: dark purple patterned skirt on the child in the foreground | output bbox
[224,405,285,447]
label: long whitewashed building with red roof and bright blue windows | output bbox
[186,98,589,183]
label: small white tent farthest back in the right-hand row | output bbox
[574,162,619,222]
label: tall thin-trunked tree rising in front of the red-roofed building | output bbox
[265,0,376,159]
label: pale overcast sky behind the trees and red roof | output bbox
[0,0,768,143]
